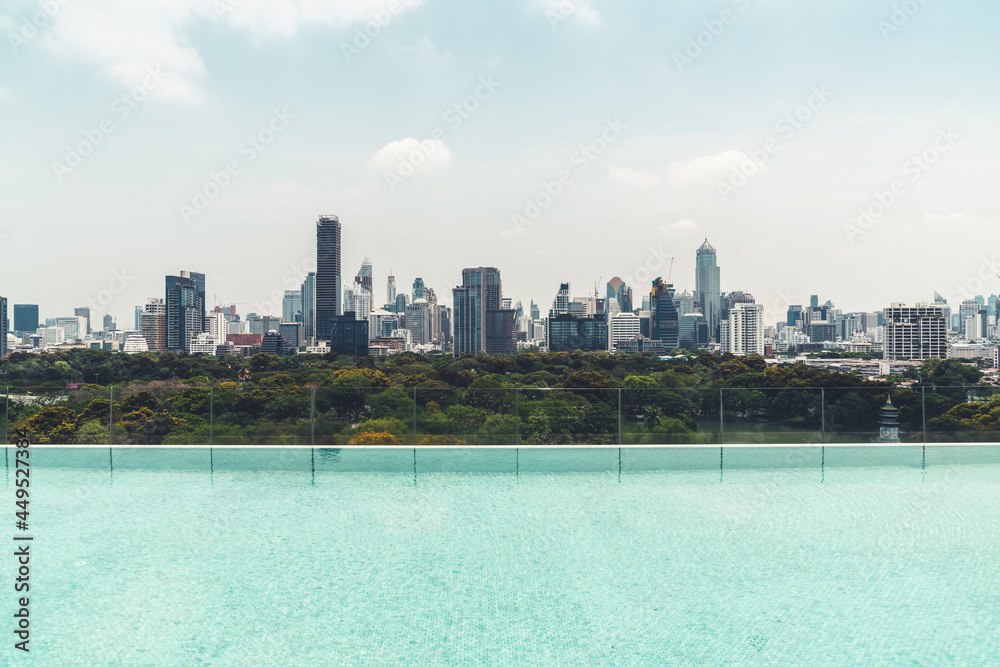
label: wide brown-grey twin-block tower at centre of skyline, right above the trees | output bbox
[452,267,517,357]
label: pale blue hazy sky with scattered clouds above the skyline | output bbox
[0,0,1000,328]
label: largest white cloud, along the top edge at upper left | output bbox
[39,0,423,101]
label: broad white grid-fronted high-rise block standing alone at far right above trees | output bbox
[882,303,948,361]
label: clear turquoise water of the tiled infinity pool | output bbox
[0,446,1000,667]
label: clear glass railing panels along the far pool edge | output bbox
[2,383,1000,448]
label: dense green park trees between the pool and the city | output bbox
[0,350,988,446]
